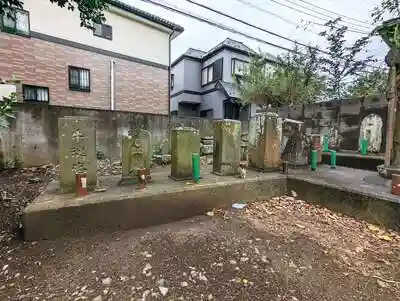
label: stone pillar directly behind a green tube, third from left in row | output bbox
[170,127,200,181]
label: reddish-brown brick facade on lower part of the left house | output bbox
[0,32,169,114]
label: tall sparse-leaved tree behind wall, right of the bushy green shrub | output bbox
[320,18,373,99]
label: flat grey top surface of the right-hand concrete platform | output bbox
[289,165,400,203]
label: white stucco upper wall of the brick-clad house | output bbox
[24,0,170,65]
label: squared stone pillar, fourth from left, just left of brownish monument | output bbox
[213,119,241,176]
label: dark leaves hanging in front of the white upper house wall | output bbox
[0,0,107,29]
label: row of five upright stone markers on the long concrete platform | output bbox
[58,113,282,195]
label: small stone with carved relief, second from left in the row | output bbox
[120,128,152,185]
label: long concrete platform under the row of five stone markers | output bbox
[23,171,286,240]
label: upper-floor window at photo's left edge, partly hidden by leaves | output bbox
[0,9,30,36]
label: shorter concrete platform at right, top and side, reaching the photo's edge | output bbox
[287,166,400,229]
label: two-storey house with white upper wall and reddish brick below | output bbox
[0,0,183,114]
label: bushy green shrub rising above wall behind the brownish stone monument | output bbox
[236,47,325,108]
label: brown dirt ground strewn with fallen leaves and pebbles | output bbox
[0,169,400,301]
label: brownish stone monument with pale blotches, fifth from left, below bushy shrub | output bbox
[248,112,282,171]
